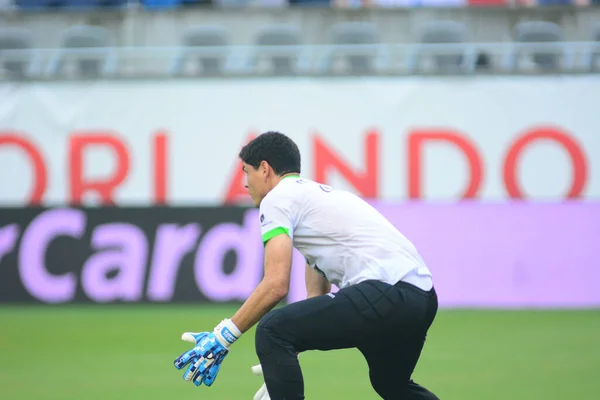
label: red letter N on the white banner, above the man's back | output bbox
[314,131,379,198]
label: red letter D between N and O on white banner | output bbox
[408,129,483,199]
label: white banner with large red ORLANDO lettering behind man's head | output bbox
[0,76,600,205]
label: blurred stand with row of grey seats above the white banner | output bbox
[0,0,600,79]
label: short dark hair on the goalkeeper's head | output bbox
[239,131,300,176]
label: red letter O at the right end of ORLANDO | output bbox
[504,127,587,199]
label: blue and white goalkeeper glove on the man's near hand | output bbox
[174,319,242,386]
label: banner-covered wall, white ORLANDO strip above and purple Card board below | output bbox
[0,75,600,308]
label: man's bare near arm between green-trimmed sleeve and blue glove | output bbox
[231,235,292,333]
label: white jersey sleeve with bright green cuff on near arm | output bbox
[260,191,294,244]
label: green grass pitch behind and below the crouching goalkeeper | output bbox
[0,305,600,400]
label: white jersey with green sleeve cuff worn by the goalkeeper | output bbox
[260,175,432,290]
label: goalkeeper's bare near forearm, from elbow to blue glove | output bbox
[231,280,288,333]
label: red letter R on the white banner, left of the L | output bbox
[69,133,129,205]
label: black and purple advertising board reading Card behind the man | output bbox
[0,202,600,308]
